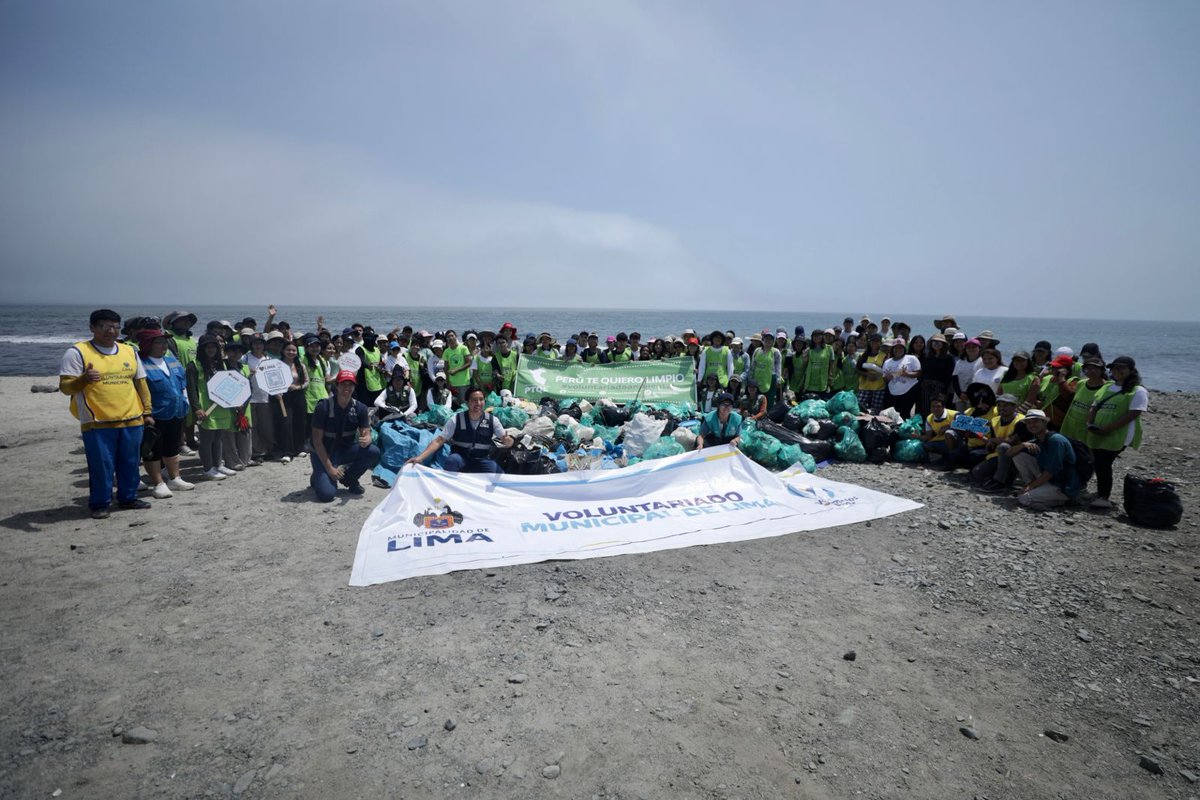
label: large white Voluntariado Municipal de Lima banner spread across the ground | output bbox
[350,445,920,587]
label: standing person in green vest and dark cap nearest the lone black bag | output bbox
[1087,355,1150,511]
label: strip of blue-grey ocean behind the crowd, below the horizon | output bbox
[0,306,1200,391]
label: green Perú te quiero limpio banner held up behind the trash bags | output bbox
[512,355,696,405]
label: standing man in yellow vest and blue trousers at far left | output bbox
[59,308,154,519]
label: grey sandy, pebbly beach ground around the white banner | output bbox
[0,378,1200,800]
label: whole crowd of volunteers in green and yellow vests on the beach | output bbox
[60,306,1148,517]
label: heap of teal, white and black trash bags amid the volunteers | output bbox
[376,391,925,486]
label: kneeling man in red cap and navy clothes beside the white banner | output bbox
[310,369,379,503]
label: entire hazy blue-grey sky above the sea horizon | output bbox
[0,0,1200,320]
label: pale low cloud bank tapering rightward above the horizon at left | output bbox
[0,114,719,307]
